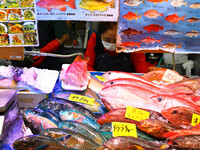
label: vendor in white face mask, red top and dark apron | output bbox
[85,22,148,73]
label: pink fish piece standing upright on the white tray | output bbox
[60,57,90,87]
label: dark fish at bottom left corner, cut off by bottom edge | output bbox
[13,135,70,150]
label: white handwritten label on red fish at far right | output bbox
[162,69,183,83]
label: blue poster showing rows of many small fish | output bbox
[116,0,200,53]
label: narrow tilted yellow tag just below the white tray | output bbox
[68,94,95,105]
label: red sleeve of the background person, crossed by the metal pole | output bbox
[33,39,60,66]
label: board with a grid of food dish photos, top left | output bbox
[0,0,38,47]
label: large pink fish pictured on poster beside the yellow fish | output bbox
[36,0,76,11]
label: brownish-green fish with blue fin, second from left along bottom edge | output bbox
[40,128,104,150]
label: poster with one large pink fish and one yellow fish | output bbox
[36,0,119,21]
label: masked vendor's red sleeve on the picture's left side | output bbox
[85,33,96,71]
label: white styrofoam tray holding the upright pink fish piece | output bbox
[61,64,87,91]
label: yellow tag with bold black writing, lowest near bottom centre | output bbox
[112,122,137,138]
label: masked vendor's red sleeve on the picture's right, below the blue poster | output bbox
[131,53,148,73]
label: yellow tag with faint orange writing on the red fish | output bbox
[125,106,150,121]
